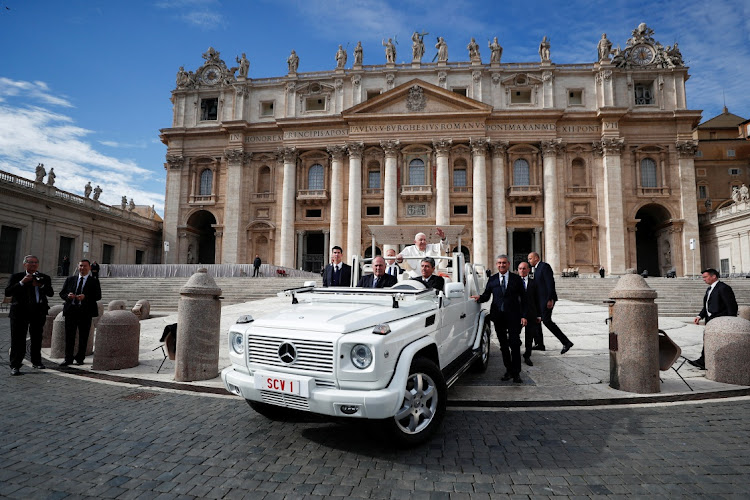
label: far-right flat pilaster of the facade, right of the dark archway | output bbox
[677,141,704,276]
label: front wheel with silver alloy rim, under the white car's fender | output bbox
[383,358,448,446]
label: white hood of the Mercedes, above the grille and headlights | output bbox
[248,300,437,333]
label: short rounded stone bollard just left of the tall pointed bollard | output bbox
[91,310,141,370]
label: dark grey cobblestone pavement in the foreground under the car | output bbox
[0,364,750,499]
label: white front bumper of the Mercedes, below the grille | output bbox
[221,366,403,419]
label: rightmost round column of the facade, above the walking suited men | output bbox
[542,139,563,274]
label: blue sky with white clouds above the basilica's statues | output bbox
[0,0,750,213]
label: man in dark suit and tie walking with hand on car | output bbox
[472,255,527,383]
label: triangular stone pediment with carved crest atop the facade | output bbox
[342,79,492,119]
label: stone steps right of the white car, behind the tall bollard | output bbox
[555,277,750,317]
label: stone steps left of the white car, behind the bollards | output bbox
[50,277,322,311]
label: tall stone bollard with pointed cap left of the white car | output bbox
[174,268,221,382]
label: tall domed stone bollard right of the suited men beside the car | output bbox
[609,274,661,394]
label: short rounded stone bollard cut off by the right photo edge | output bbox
[703,316,750,385]
